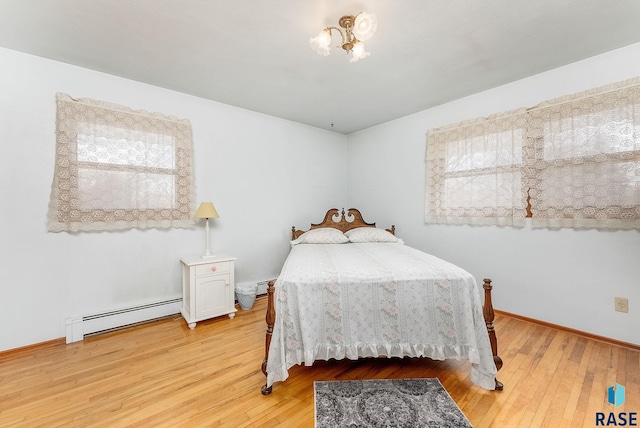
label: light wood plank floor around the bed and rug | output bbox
[0,299,640,427]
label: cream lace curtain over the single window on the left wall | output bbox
[47,93,194,232]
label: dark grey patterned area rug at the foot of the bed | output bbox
[313,379,471,428]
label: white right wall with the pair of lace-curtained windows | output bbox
[347,44,640,344]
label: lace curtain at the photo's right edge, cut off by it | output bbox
[526,79,640,229]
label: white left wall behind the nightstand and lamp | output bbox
[0,48,347,351]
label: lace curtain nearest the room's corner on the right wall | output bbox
[425,109,526,226]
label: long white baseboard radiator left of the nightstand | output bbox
[66,298,182,343]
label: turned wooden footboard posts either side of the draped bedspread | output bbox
[262,278,504,395]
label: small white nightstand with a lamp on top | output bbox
[180,254,237,329]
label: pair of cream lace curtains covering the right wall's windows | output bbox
[425,78,640,229]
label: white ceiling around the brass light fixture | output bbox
[0,0,640,134]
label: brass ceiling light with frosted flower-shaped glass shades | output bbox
[309,12,378,62]
